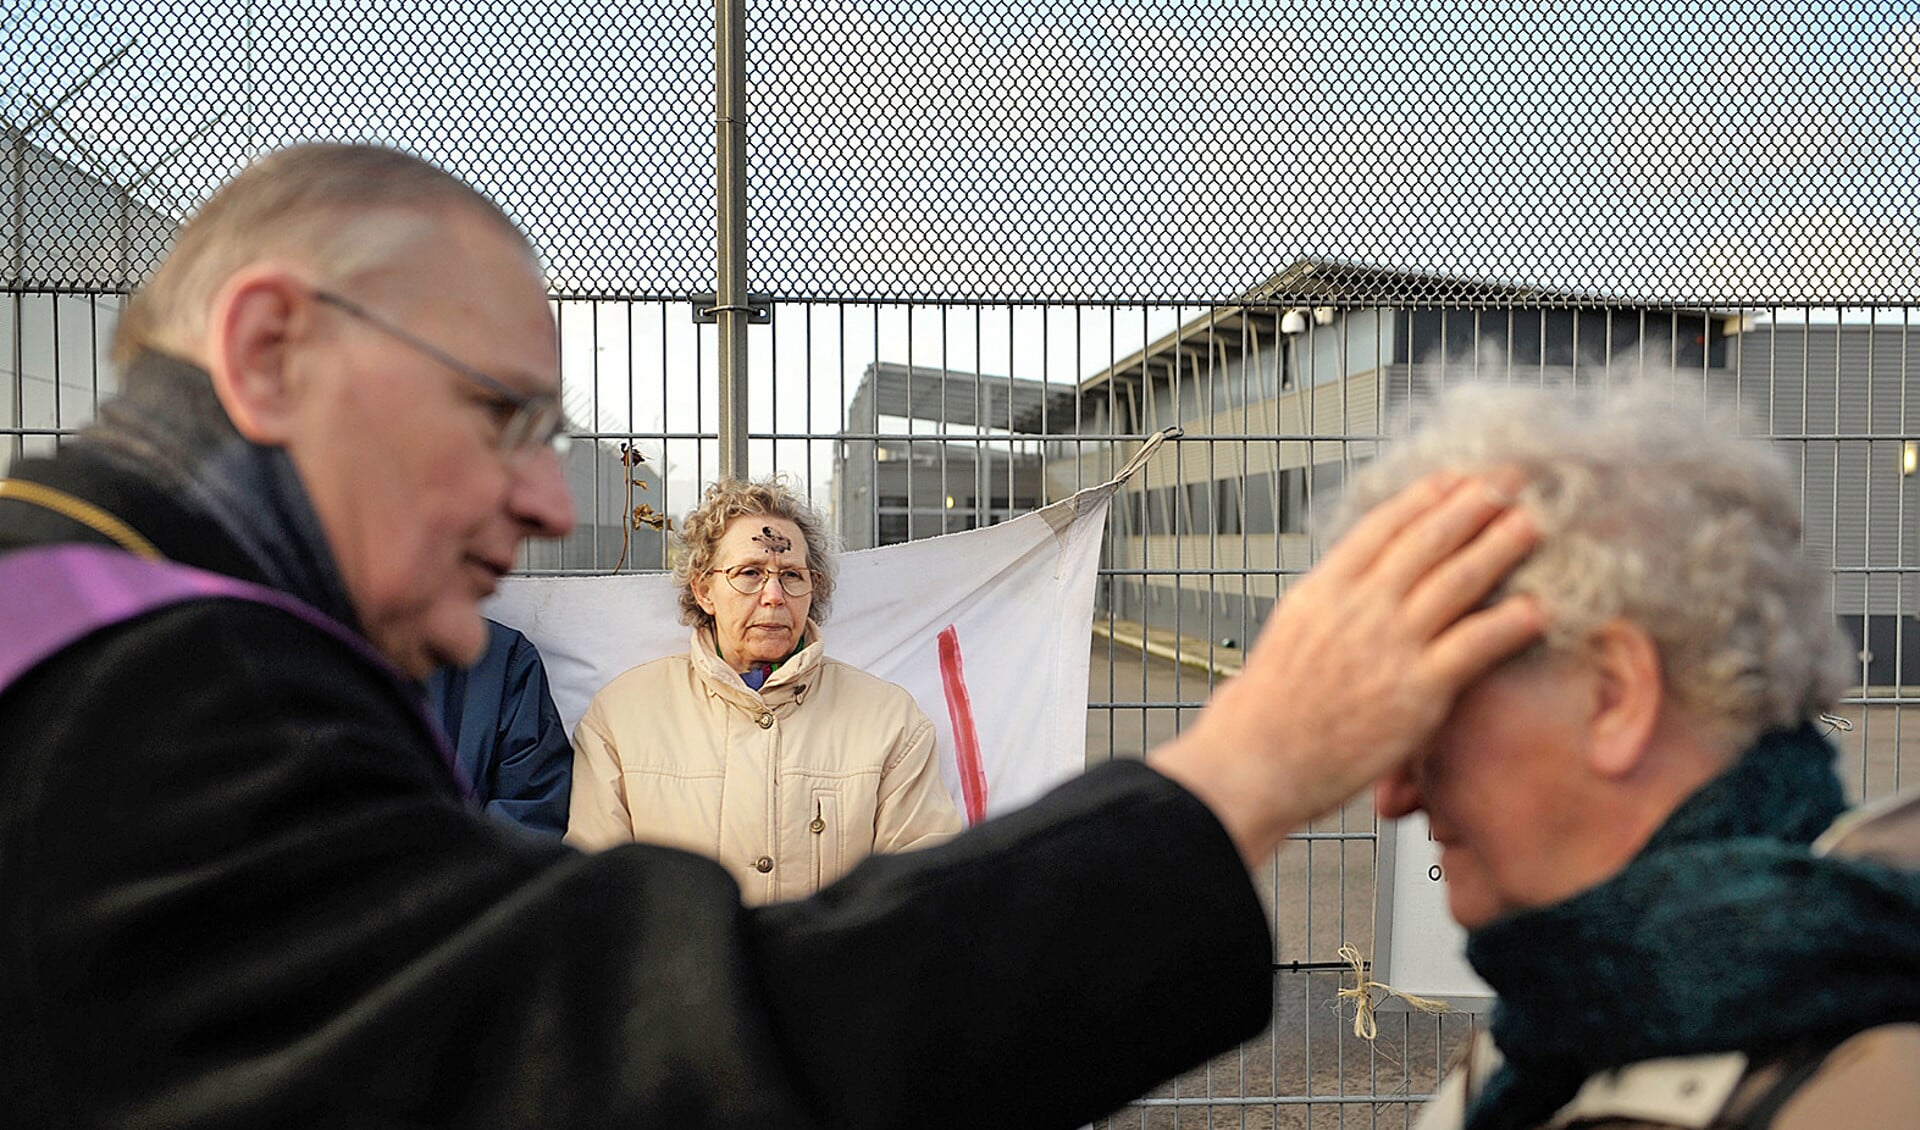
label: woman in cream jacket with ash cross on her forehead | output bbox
[566,480,960,904]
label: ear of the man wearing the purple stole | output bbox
[205,263,313,447]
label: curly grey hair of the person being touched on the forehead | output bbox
[1329,380,1851,744]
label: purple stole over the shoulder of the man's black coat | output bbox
[0,545,472,798]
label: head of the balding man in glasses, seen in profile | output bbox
[100,146,572,677]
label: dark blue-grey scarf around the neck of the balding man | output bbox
[75,351,359,631]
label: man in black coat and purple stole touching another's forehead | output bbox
[0,146,1542,1128]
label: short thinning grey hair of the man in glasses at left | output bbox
[113,144,540,365]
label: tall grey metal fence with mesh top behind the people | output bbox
[0,0,1920,1128]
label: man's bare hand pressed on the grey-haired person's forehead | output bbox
[1152,468,1546,867]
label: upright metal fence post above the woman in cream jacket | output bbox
[714,0,751,480]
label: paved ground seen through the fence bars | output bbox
[1087,624,1920,1130]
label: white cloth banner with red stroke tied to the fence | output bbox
[486,480,1121,823]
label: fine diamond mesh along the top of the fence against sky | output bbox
[11,0,1920,305]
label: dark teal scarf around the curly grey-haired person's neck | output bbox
[1467,727,1920,1130]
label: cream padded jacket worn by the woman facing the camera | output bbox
[566,624,962,904]
